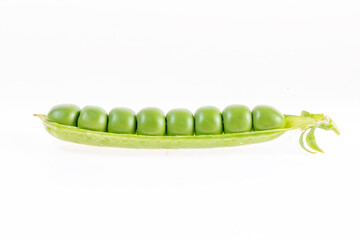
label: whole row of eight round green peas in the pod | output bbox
[47,104,285,136]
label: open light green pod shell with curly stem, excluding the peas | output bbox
[35,111,340,153]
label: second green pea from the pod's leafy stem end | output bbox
[222,105,252,133]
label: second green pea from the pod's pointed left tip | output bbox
[78,106,107,132]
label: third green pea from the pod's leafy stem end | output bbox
[195,106,223,135]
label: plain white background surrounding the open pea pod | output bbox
[0,0,360,240]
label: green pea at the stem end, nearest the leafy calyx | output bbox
[252,105,285,131]
